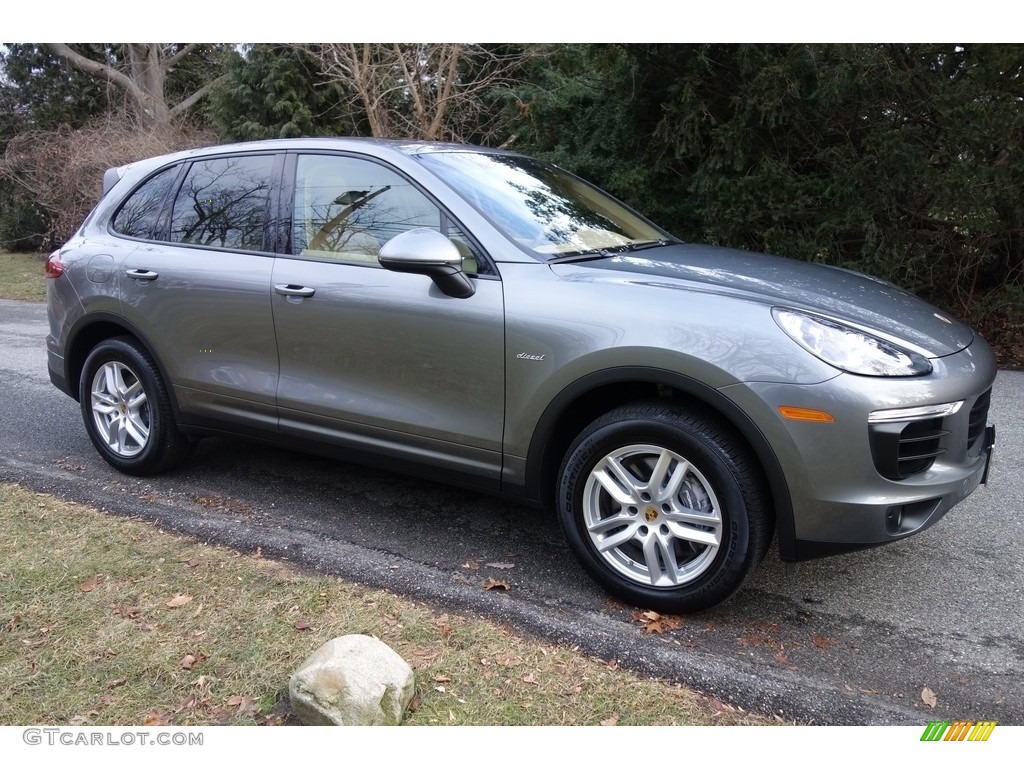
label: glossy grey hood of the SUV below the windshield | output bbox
[579,244,974,357]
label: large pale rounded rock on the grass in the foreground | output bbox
[288,635,416,725]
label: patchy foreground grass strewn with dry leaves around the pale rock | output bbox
[0,484,773,725]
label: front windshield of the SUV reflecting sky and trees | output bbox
[418,152,671,258]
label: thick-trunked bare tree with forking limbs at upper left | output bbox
[47,43,226,126]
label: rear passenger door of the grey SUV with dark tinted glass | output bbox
[113,154,283,430]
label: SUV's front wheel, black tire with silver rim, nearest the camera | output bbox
[557,401,773,613]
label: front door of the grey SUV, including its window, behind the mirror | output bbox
[272,154,505,485]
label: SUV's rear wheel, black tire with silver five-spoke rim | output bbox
[79,336,193,475]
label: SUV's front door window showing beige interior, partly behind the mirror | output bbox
[292,155,476,272]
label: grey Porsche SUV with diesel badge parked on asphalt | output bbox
[46,139,995,611]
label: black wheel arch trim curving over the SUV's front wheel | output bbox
[525,367,796,560]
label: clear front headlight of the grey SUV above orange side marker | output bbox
[772,307,932,376]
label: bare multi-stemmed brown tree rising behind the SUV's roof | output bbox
[308,43,537,142]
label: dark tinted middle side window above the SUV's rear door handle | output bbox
[171,155,273,251]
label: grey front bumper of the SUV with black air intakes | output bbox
[723,339,995,561]
